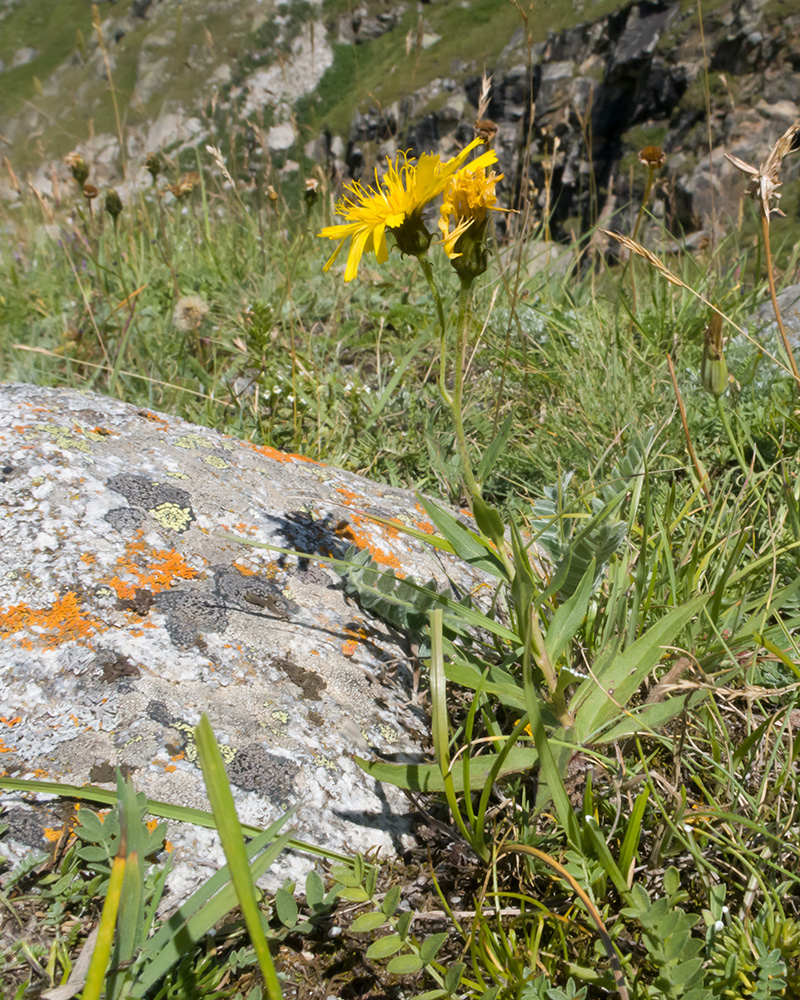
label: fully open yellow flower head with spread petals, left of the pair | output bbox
[319,139,497,281]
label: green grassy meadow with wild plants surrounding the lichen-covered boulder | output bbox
[0,72,800,1000]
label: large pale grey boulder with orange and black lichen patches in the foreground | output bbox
[0,385,478,900]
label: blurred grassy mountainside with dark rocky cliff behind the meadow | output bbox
[0,0,800,244]
